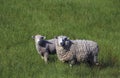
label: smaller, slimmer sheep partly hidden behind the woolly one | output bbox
[32,35,56,63]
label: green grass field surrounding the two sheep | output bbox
[0,0,120,78]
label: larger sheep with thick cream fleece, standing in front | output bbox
[56,36,99,66]
